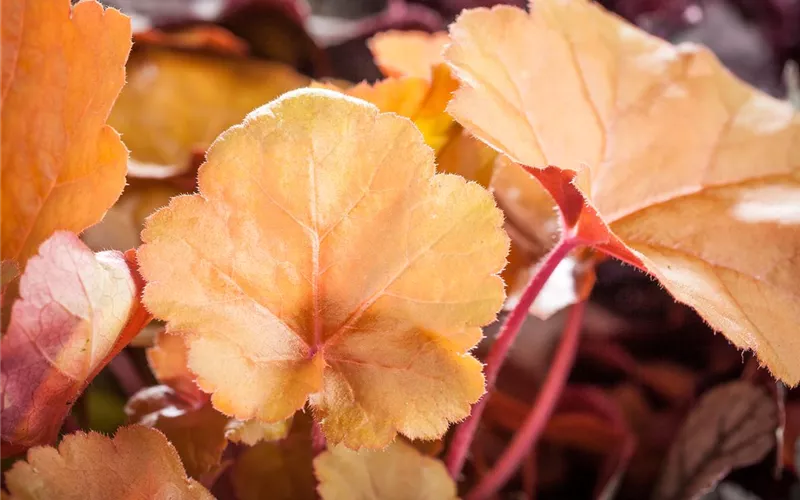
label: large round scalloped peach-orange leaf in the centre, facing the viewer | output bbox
[139,89,508,448]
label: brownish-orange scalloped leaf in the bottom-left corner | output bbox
[6,426,214,500]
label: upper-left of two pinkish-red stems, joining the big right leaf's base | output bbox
[446,234,580,481]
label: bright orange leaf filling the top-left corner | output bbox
[0,0,131,267]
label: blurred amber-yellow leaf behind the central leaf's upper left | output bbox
[109,45,308,174]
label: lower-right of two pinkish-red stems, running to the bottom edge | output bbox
[467,301,586,500]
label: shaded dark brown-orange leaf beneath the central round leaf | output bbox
[231,414,317,500]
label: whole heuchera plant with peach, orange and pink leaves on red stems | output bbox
[0,0,800,499]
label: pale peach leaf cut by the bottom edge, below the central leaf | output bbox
[314,440,457,500]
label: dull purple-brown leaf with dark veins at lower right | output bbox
[653,381,778,500]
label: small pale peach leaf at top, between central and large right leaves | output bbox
[367,30,450,79]
